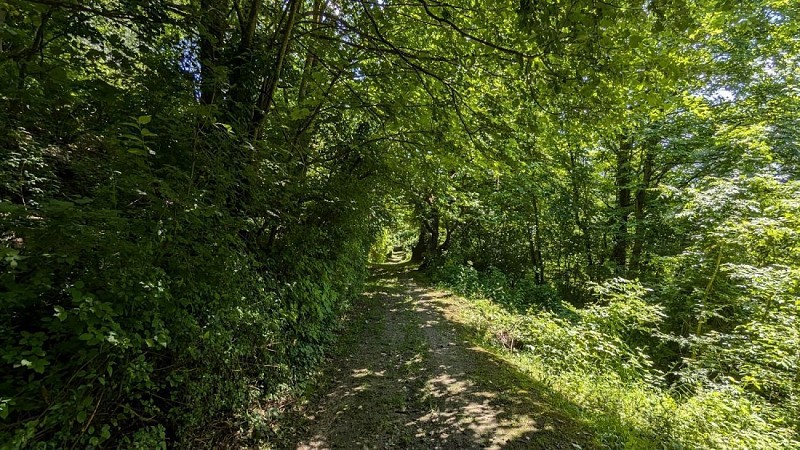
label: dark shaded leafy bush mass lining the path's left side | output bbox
[0,109,377,448]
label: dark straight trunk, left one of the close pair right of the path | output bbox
[611,138,631,275]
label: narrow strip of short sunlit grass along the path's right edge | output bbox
[444,290,800,450]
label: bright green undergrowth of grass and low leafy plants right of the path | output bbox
[437,266,800,450]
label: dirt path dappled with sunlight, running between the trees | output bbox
[282,255,594,449]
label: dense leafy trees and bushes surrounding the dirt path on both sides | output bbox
[0,0,800,448]
